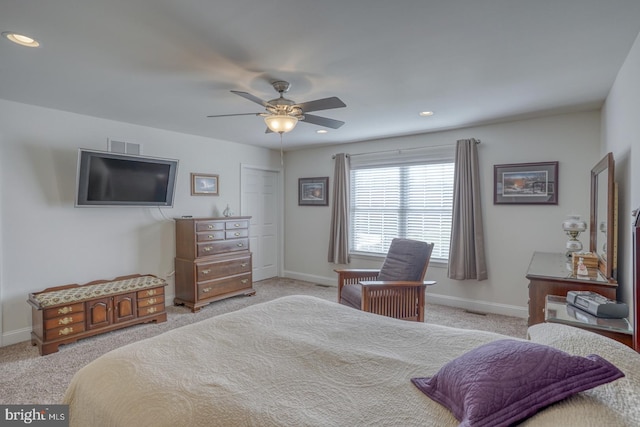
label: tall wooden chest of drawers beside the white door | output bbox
[174,216,256,313]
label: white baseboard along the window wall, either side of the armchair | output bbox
[284,271,529,319]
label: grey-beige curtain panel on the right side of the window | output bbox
[448,138,487,280]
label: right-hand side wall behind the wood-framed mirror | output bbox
[602,30,640,320]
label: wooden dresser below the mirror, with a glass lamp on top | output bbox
[527,252,618,326]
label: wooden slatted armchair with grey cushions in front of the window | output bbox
[334,239,436,322]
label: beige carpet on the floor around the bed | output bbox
[0,279,527,404]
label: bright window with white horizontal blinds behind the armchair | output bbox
[350,152,454,260]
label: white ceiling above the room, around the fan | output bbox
[0,0,640,149]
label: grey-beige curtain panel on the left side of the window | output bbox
[328,153,350,264]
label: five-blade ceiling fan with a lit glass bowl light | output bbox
[207,80,346,134]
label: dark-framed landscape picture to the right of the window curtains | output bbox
[493,162,558,205]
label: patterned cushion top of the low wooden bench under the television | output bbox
[32,276,167,307]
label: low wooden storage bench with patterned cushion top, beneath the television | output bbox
[28,274,167,356]
